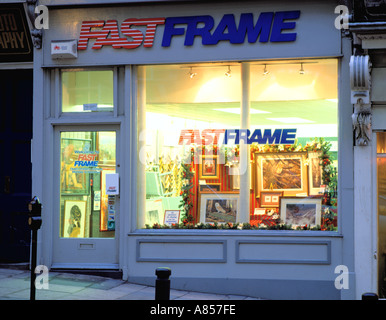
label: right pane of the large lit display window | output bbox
[250,59,338,230]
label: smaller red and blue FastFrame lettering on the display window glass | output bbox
[178,129,296,145]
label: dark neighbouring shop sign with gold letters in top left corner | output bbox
[0,6,32,62]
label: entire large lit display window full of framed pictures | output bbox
[138,59,338,230]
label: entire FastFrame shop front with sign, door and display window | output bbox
[32,1,355,299]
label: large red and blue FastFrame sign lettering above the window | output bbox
[78,10,300,50]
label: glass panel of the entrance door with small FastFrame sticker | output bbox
[59,132,116,238]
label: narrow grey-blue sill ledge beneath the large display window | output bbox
[127,229,343,238]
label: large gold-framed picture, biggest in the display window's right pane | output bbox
[255,152,308,197]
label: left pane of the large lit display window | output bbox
[138,64,240,228]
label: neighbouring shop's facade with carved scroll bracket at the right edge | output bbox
[349,1,386,298]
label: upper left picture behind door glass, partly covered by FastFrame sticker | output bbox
[60,138,91,195]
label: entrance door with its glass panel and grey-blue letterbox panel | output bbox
[53,130,119,268]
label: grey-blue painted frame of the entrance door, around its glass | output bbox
[50,124,123,269]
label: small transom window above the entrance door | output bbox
[61,70,114,112]
